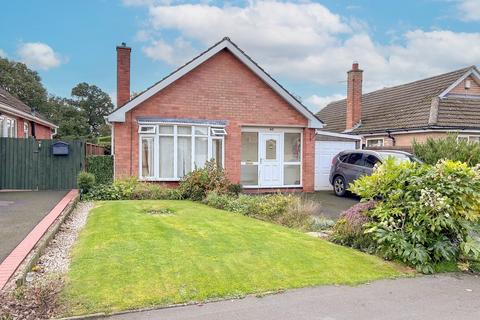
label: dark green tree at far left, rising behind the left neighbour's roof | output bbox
[0,58,48,113]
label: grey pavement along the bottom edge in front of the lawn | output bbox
[108,274,480,320]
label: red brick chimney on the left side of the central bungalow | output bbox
[117,42,132,108]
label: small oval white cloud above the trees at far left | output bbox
[17,42,65,70]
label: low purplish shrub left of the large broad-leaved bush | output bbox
[330,200,375,252]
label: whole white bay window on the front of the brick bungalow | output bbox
[139,124,226,181]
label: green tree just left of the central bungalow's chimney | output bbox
[71,82,113,137]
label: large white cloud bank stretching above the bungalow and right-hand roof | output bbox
[133,1,480,92]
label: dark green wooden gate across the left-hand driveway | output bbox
[0,138,85,190]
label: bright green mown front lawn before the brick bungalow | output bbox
[64,201,401,314]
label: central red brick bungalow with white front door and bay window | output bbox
[108,38,323,191]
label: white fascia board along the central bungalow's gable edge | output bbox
[107,39,324,129]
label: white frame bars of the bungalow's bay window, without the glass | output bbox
[138,123,225,182]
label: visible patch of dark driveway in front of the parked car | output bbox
[303,191,360,219]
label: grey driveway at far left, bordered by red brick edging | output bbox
[0,191,67,263]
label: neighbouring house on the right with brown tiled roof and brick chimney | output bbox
[317,63,480,148]
